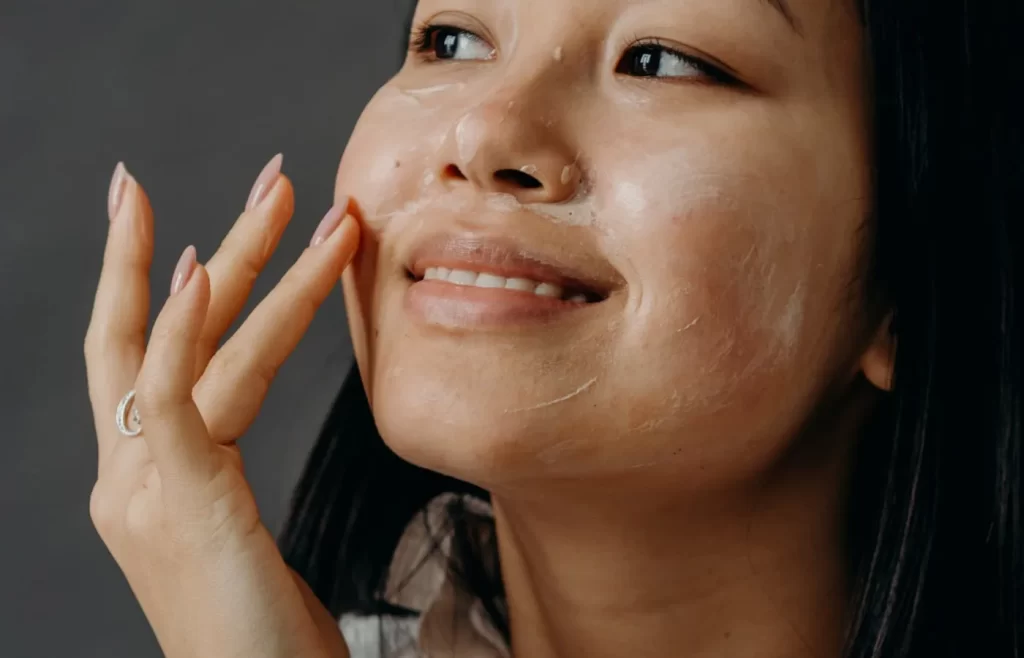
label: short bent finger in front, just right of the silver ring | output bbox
[135,252,218,489]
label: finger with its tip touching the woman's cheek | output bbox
[195,206,359,443]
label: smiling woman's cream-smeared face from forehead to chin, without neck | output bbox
[337,0,871,489]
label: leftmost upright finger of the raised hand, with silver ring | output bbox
[85,163,153,463]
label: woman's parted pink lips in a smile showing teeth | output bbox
[404,232,622,328]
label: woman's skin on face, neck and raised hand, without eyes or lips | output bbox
[84,0,891,658]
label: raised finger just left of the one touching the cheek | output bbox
[196,153,295,378]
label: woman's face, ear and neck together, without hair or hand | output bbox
[336,0,889,658]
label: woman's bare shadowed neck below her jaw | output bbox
[494,452,847,658]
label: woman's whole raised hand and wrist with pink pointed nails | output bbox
[85,158,359,658]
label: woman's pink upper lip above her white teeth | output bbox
[404,230,623,299]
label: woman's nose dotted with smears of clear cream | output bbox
[439,97,581,204]
